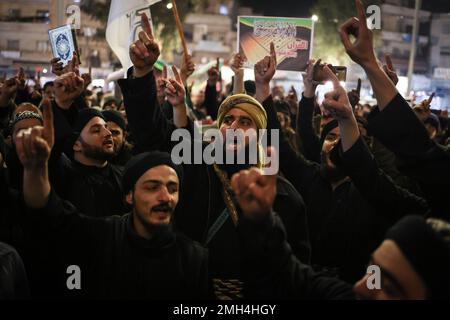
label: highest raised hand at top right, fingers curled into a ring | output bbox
[339,0,377,68]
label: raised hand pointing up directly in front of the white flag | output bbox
[129,13,161,77]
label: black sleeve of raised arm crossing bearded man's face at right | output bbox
[333,137,429,222]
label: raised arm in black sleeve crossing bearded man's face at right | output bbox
[323,67,428,222]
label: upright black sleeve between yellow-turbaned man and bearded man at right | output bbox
[296,95,321,163]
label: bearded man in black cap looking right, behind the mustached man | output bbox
[50,108,127,217]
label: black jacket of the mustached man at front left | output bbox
[23,191,208,299]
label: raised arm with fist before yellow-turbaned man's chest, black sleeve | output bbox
[231,168,354,299]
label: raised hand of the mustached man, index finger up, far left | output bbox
[15,99,54,170]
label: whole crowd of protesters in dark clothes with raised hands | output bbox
[0,0,450,300]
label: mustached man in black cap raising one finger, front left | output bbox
[17,106,208,299]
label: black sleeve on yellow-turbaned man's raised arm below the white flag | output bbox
[119,68,176,153]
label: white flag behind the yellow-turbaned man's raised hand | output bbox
[106,0,161,73]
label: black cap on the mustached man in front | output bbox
[122,151,183,194]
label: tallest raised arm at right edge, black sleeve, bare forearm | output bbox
[340,1,450,220]
